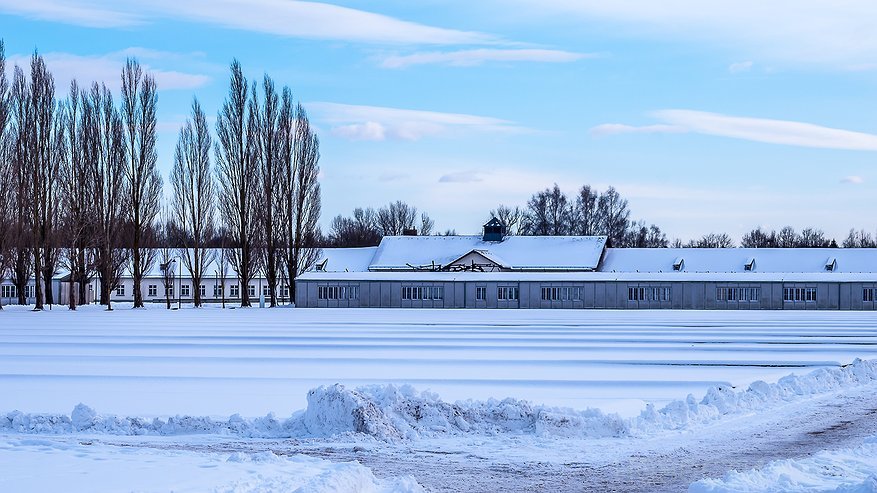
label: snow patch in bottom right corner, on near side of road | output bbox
[688,436,877,493]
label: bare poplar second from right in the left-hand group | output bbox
[83,83,130,310]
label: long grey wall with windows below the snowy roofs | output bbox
[296,280,877,310]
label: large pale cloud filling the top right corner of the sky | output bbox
[510,0,877,68]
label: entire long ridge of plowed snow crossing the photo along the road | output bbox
[6,359,877,441]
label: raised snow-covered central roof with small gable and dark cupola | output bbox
[370,235,606,271]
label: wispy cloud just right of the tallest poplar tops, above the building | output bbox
[306,102,526,141]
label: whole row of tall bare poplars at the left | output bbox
[0,40,321,310]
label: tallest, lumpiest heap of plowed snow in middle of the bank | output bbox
[302,384,626,440]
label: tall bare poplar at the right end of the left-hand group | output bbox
[122,58,162,308]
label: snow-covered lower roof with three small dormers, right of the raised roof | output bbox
[599,248,877,275]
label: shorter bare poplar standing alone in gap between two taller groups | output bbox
[171,99,216,307]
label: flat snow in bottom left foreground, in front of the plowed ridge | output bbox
[0,436,424,493]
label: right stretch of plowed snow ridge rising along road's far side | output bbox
[630,359,877,435]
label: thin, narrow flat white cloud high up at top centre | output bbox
[381,48,596,68]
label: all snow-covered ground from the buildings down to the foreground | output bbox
[0,306,877,491]
